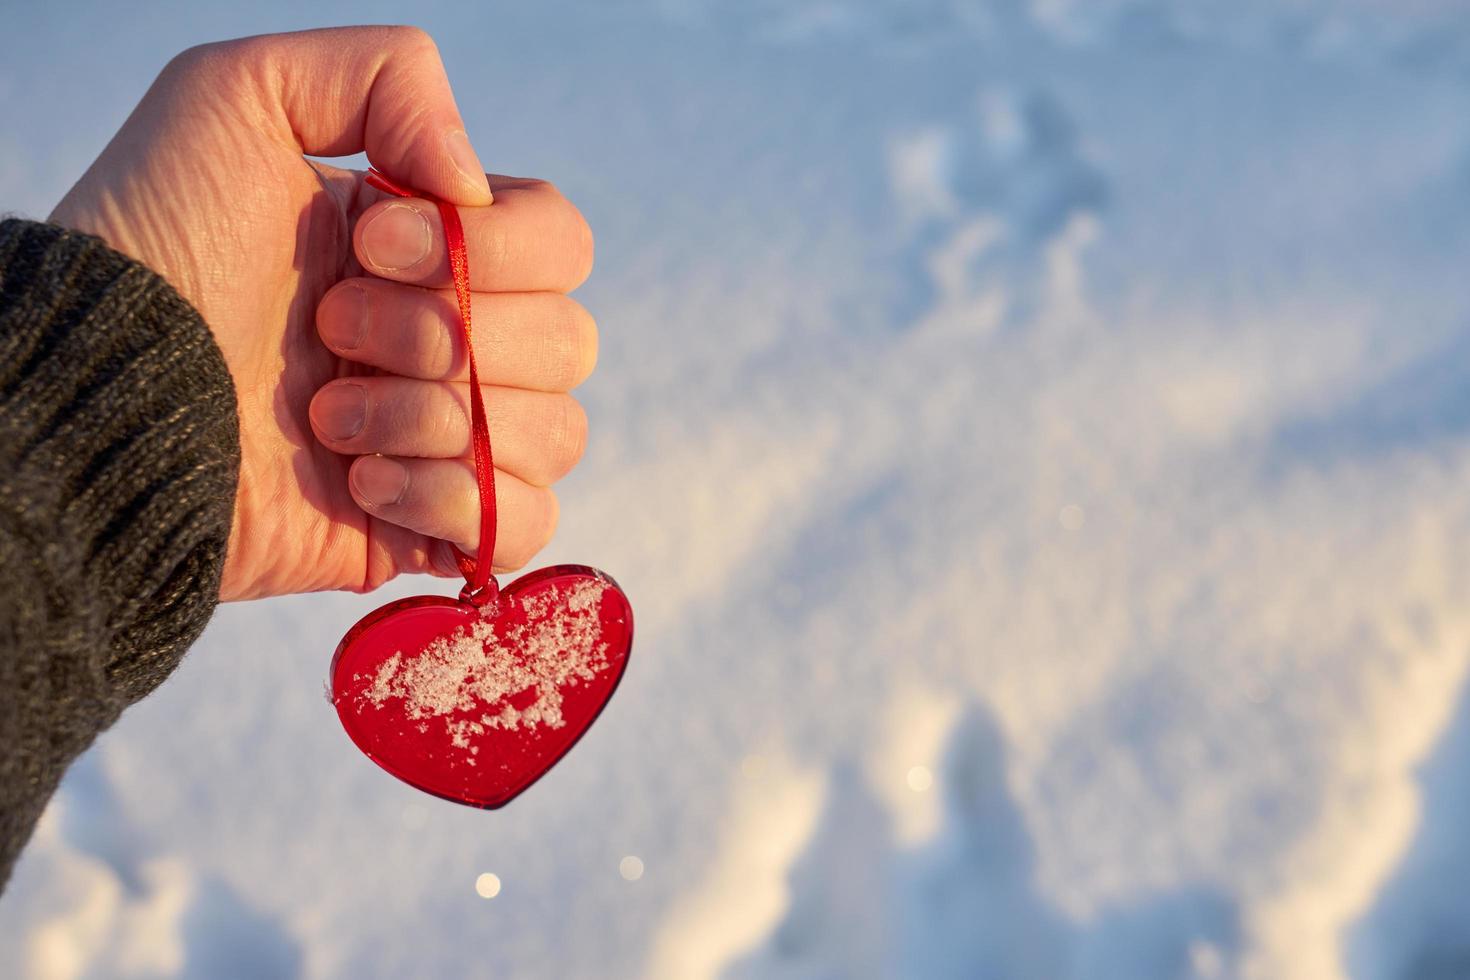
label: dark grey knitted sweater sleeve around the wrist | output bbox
[0,220,240,887]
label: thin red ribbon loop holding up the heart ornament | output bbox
[366,169,497,605]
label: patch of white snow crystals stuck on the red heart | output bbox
[353,579,609,746]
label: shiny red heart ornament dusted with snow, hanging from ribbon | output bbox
[332,564,634,810]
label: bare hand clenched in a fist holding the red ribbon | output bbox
[51,28,597,599]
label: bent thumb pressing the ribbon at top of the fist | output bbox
[204,26,491,206]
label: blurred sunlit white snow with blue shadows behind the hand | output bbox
[0,0,1470,980]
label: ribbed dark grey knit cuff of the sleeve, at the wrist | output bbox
[0,220,240,704]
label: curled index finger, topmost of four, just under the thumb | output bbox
[353,176,592,292]
